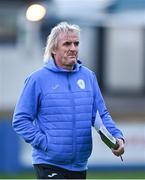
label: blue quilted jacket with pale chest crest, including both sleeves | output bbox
[13,59,122,171]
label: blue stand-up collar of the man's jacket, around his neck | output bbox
[44,58,82,72]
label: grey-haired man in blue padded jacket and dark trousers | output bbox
[13,22,124,179]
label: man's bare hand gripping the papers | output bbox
[112,139,124,156]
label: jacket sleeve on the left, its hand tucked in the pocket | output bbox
[12,77,47,151]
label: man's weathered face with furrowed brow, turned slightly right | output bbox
[53,32,79,70]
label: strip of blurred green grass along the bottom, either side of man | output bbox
[0,170,145,179]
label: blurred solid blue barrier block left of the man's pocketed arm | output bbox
[0,119,21,172]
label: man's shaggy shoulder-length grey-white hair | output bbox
[43,22,80,63]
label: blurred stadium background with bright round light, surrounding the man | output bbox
[0,0,145,178]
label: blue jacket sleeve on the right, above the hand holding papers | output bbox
[93,74,124,139]
